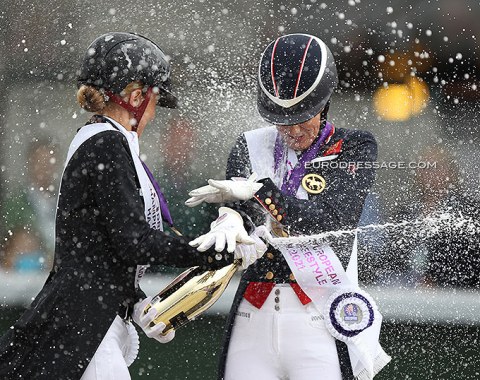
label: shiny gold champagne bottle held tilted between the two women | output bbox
[144,260,241,335]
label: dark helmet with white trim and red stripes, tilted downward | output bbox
[257,34,338,125]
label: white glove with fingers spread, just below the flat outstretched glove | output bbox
[189,207,255,253]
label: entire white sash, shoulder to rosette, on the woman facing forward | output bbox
[245,127,390,380]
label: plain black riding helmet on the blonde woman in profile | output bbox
[77,32,177,108]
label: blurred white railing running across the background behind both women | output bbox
[0,272,480,324]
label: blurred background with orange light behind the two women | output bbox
[0,0,480,379]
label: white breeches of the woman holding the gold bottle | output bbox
[80,315,138,380]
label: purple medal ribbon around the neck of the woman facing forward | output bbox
[274,121,333,196]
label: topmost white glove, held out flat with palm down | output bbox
[185,173,263,207]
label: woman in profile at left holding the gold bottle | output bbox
[0,33,258,380]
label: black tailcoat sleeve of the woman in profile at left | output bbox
[83,131,233,269]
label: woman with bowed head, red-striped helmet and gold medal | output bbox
[186,34,389,380]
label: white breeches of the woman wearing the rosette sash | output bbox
[225,285,342,380]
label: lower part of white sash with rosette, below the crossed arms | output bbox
[269,236,390,380]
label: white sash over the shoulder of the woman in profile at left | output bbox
[65,118,163,288]
